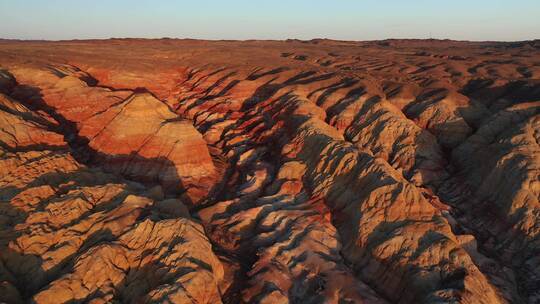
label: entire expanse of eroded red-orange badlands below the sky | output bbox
[0,39,540,304]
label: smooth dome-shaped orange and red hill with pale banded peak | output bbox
[79,93,217,203]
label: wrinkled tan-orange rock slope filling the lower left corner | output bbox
[0,93,223,303]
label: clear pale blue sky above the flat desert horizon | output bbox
[0,0,540,41]
